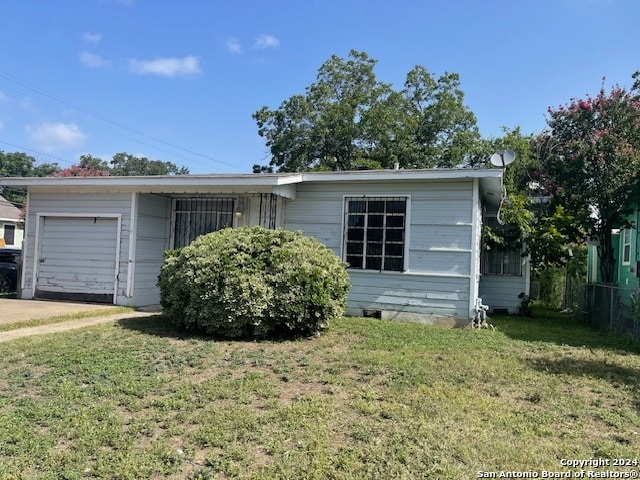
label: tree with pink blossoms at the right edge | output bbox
[540,80,640,283]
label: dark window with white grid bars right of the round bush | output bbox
[344,197,407,272]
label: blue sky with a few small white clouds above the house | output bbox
[0,0,640,173]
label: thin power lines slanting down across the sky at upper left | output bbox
[0,70,240,168]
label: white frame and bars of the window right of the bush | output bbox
[341,194,411,274]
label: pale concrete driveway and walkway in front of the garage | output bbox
[0,298,159,342]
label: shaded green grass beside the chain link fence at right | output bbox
[492,308,640,354]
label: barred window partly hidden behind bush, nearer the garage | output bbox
[173,198,235,248]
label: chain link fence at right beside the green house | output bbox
[577,284,640,343]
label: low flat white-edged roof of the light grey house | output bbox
[0,169,503,203]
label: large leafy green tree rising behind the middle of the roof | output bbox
[253,50,480,171]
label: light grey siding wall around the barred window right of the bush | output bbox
[284,181,473,324]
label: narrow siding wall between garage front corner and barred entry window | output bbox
[131,194,171,306]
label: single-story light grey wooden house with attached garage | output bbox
[1,169,525,325]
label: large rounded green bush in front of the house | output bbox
[158,227,350,338]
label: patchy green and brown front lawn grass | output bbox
[0,312,640,480]
